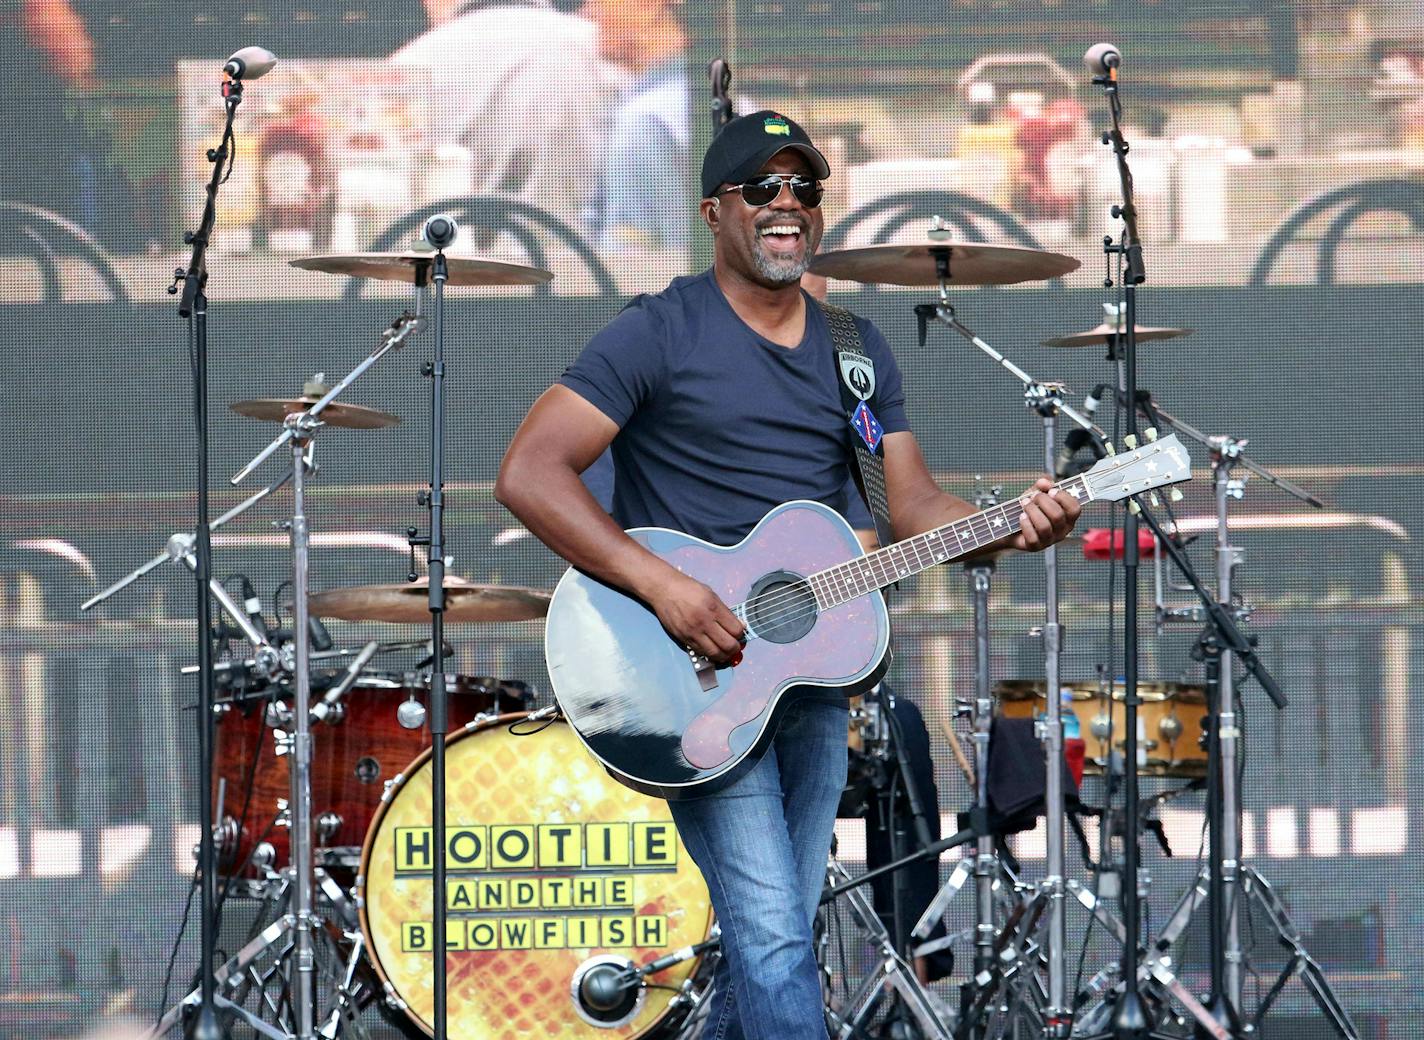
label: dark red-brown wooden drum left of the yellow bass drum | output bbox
[214,672,534,878]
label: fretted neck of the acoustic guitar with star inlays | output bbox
[806,474,1094,610]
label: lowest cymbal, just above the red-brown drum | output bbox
[312,577,550,624]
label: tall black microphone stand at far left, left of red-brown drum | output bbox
[168,64,242,1040]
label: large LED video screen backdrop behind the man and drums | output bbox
[0,0,1424,1039]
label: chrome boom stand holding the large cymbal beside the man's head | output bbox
[914,264,1102,1037]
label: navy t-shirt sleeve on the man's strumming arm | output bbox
[558,301,668,429]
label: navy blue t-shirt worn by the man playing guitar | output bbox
[560,271,910,546]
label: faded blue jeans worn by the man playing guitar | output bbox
[671,702,846,1040]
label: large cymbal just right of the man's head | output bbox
[809,241,1081,285]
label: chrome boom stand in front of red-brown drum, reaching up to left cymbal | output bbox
[232,315,420,1040]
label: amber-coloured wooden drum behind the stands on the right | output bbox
[994,680,1206,778]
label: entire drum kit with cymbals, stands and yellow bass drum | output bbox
[84,205,1353,1040]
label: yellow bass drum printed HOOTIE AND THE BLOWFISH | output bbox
[356,714,712,1040]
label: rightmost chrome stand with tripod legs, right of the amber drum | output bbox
[1122,392,1358,1040]
